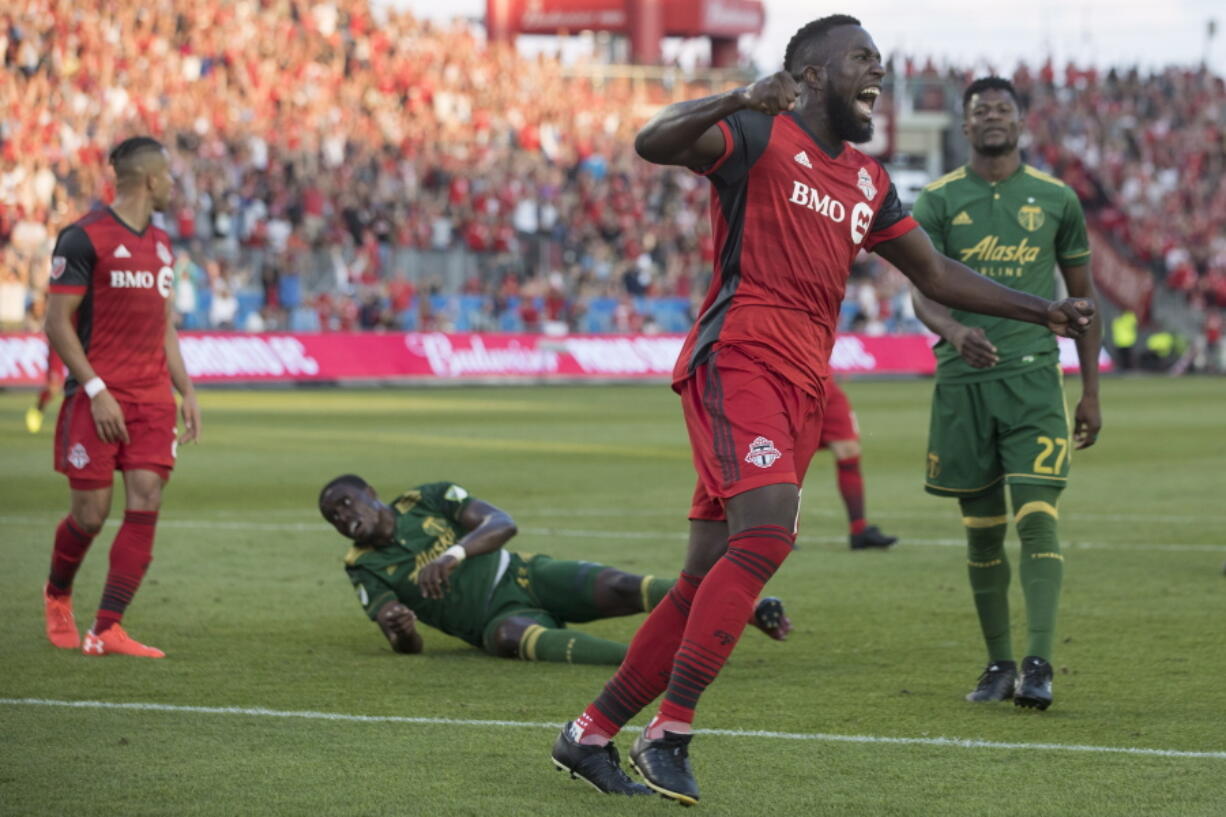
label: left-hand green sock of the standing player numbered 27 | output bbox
[959,486,1013,661]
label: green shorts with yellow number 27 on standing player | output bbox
[924,366,1073,497]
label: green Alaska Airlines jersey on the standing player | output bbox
[912,164,1090,383]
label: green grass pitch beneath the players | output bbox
[0,379,1226,817]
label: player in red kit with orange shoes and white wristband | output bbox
[43,136,200,658]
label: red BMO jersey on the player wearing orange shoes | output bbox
[50,207,174,402]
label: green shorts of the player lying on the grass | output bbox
[482,552,606,646]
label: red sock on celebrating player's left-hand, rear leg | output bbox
[575,573,704,742]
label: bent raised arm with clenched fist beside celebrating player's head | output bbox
[634,71,801,168]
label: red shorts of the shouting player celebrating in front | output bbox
[674,346,825,520]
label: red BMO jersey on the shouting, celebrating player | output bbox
[673,110,918,396]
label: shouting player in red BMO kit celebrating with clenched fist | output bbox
[553,15,1094,805]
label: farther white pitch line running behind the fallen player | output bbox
[0,515,1226,553]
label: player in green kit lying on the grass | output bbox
[319,474,792,665]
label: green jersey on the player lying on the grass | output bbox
[345,482,508,646]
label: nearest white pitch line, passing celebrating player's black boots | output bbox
[0,698,1226,761]
